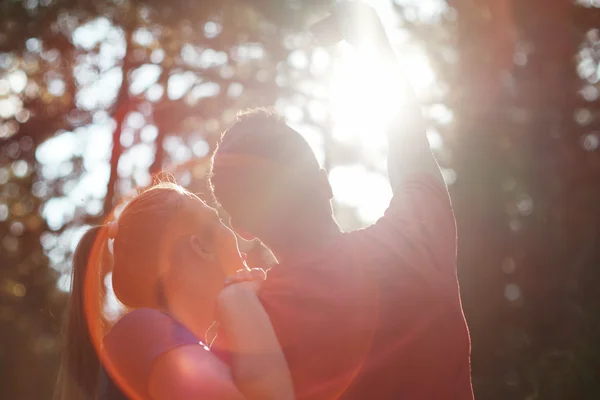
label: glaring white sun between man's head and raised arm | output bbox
[329,34,436,224]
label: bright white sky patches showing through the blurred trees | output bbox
[12,0,452,289]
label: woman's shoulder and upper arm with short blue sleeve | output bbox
[103,309,244,400]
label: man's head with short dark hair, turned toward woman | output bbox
[210,109,333,247]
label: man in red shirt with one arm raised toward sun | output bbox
[211,6,473,400]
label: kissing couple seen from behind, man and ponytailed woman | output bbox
[57,3,473,400]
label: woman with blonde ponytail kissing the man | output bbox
[57,183,293,400]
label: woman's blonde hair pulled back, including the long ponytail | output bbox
[54,182,194,400]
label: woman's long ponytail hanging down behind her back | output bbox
[54,226,107,400]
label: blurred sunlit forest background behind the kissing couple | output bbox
[0,0,600,400]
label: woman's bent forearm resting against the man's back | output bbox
[219,282,294,400]
